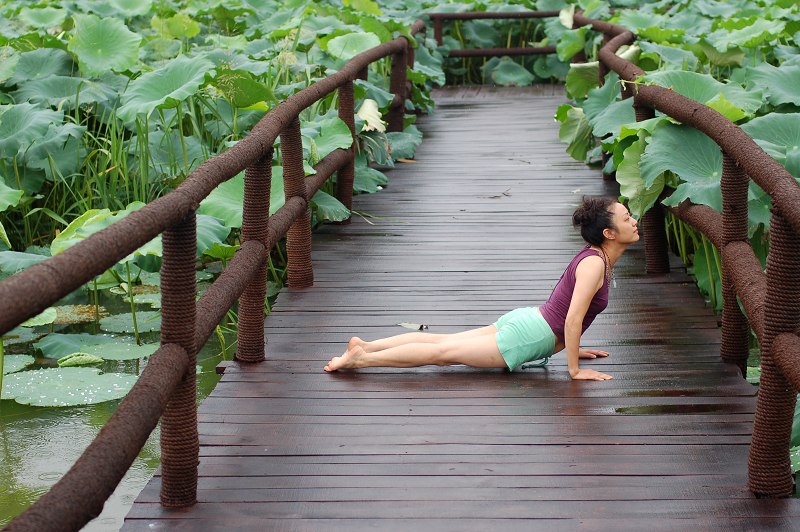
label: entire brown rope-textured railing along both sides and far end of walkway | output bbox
[0,7,800,531]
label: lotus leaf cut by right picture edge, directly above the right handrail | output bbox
[741,113,800,179]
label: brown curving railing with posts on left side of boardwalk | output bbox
[0,20,425,531]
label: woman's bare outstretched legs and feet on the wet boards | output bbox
[325,330,506,371]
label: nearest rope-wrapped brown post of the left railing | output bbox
[161,213,200,508]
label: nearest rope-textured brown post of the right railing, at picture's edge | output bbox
[748,210,800,497]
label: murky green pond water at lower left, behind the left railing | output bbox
[0,280,235,532]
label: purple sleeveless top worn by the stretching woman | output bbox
[539,246,608,341]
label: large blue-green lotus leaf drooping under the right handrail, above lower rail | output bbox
[640,123,722,212]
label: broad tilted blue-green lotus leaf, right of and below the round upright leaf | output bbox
[117,55,214,121]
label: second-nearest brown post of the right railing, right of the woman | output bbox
[719,152,750,376]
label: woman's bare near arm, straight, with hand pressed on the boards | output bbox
[564,256,612,380]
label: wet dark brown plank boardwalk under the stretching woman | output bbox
[123,87,800,531]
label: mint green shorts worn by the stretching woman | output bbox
[494,307,556,371]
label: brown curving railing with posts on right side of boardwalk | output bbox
[574,13,800,497]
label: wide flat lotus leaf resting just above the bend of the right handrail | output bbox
[644,71,761,116]
